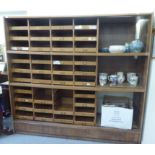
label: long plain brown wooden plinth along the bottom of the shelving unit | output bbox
[14,120,141,143]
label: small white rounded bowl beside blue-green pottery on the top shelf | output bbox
[109,45,125,53]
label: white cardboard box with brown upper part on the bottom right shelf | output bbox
[101,96,133,129]
